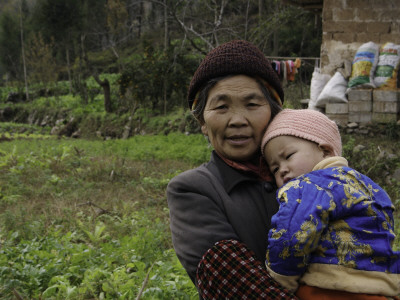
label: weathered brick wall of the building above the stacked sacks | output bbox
[321,0,400,75]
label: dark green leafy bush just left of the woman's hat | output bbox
[119,41,199,113]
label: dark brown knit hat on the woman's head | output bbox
[188,40,284,109]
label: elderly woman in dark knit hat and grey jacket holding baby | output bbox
[167,41,296,299]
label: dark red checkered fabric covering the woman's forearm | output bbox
[197,240,298,300]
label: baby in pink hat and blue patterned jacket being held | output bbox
[261,109,400,299]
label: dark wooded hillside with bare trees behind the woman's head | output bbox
[0,0,322,122]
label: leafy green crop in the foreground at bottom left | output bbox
[0,227,196,299]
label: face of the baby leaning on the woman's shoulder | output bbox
[264,135,326,187]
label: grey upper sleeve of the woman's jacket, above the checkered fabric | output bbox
[167,168,238,286]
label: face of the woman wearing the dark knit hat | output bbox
[201,75,271,161]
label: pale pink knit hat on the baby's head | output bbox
[261,109,342,156]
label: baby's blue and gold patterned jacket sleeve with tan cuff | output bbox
[266,180,336,291]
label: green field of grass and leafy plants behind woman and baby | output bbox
[0,127,400,299]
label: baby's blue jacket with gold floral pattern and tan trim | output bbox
[266,157,400,296]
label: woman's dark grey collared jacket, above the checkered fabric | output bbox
[167,152,278,285]
